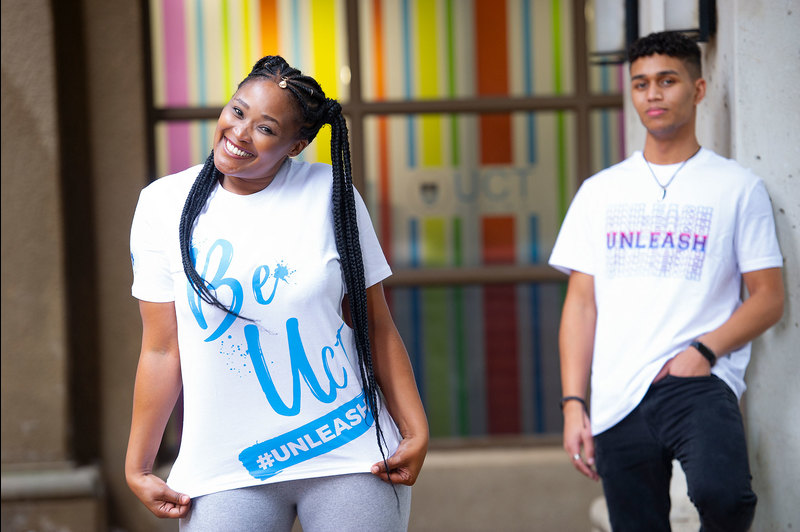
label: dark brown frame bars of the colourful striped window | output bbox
[142,0,623,286]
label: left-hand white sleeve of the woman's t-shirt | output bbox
[130,188,175,303]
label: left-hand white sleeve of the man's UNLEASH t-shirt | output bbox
[548,182,597,275]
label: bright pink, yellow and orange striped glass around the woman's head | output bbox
[149,0,349,175]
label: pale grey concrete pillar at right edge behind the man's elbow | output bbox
[732,0,800,530]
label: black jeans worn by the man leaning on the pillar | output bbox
[595,375,756,532]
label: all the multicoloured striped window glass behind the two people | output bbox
[150,0,624,436]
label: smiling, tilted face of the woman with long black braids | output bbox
[214,79,308,194]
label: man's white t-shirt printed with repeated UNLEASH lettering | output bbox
[550,149,783,434]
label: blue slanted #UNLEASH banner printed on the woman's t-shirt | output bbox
[239,392,374,480]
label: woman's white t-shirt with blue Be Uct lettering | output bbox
[131,159,400,497]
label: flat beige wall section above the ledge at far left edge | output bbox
[2,0,69,465]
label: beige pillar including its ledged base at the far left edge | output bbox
[0,0,104,530]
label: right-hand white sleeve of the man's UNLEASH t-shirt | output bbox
[735,179,783,273]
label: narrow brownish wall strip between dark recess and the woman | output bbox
[83,0,169,531]
